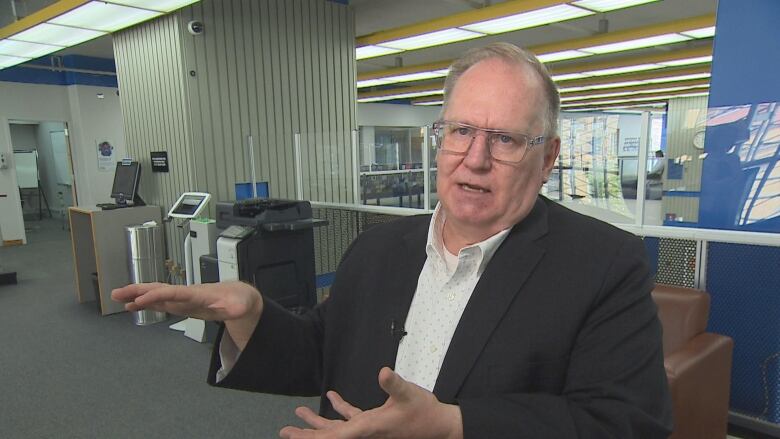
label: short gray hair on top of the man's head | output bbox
[442,43,561,136]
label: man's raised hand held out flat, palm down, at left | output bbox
[111,282,263,350]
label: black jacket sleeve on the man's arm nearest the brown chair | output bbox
[457,238,671,439]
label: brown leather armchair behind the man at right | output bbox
[652,284,734,439]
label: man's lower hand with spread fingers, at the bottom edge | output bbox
[279,367,463,439]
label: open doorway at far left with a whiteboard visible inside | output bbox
[9,120,78,243]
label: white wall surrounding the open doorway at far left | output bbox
[0,82,126,243]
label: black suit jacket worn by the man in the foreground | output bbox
[209,197,671,439]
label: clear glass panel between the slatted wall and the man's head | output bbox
[358,126,424,209]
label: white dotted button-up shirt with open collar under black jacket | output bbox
[395,205,509,391]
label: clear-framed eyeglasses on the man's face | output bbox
[433,120,545,163]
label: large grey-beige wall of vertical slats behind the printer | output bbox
[114,0,357,272]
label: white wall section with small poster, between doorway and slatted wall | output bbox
[68,85,125,210]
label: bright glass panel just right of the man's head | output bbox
[541,113,640,223]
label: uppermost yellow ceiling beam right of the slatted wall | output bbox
[355,0,567,47]
